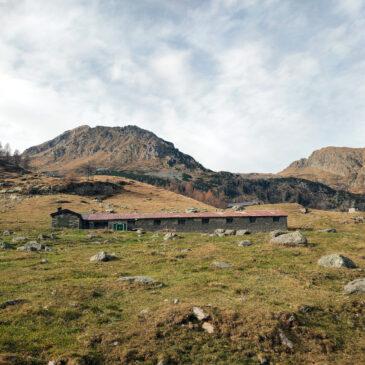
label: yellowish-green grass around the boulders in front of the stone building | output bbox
[0,225,365,364]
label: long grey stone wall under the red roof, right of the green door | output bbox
[109,217,287,233]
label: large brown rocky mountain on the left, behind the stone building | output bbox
[23,126,205,174]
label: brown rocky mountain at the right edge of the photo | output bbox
[279,147,365,194]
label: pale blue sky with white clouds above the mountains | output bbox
[0,0,365,173]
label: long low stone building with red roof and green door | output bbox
[51,208,287,232]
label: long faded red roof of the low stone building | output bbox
[82,210,287,221]
